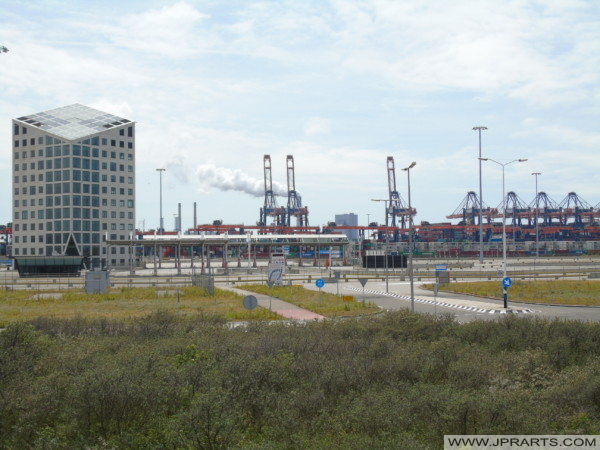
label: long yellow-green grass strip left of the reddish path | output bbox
[0,287,281,327]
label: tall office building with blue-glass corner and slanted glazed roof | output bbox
[12,104,135,268]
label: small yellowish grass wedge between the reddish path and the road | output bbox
[239,284,380,317]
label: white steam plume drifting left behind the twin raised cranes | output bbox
[196,164,287,197]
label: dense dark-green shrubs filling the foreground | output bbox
[0,311,600,449]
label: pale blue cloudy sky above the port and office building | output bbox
[0,0,600,229]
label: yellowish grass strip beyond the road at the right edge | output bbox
[424,280,600,306]
